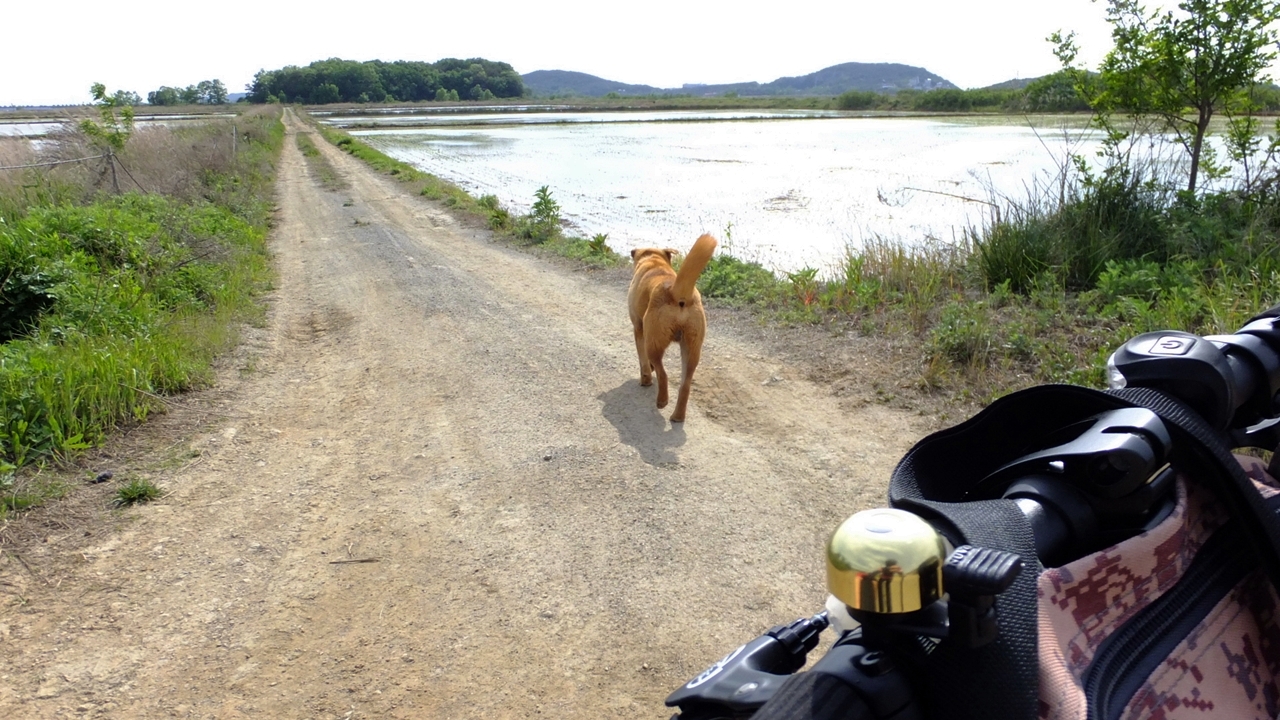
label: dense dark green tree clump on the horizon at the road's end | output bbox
[246,58,525,105]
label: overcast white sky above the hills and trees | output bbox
[0,0,1110,105]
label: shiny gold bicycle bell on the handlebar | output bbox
[827,507,947,614]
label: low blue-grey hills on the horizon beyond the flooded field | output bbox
[520,63,956,97]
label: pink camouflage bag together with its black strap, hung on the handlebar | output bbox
[890,386,1280,720]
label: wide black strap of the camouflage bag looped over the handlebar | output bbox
[890,379,1280,720]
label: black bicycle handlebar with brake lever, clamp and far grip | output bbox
[667,305,1280,720]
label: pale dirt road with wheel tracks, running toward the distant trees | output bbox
[0,109,927,719]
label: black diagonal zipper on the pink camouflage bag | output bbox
[1084,524,1258,720]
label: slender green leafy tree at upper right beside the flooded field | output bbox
[1070,0,1280,192]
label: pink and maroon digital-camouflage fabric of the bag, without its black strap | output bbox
[1037,456,1280,720]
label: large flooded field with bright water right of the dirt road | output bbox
[325,108,1092,270]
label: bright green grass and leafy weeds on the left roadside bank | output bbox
[0,195,269,466]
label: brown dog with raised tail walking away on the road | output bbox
[627,234,716,423]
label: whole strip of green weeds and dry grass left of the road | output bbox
[0,85,284,518]
